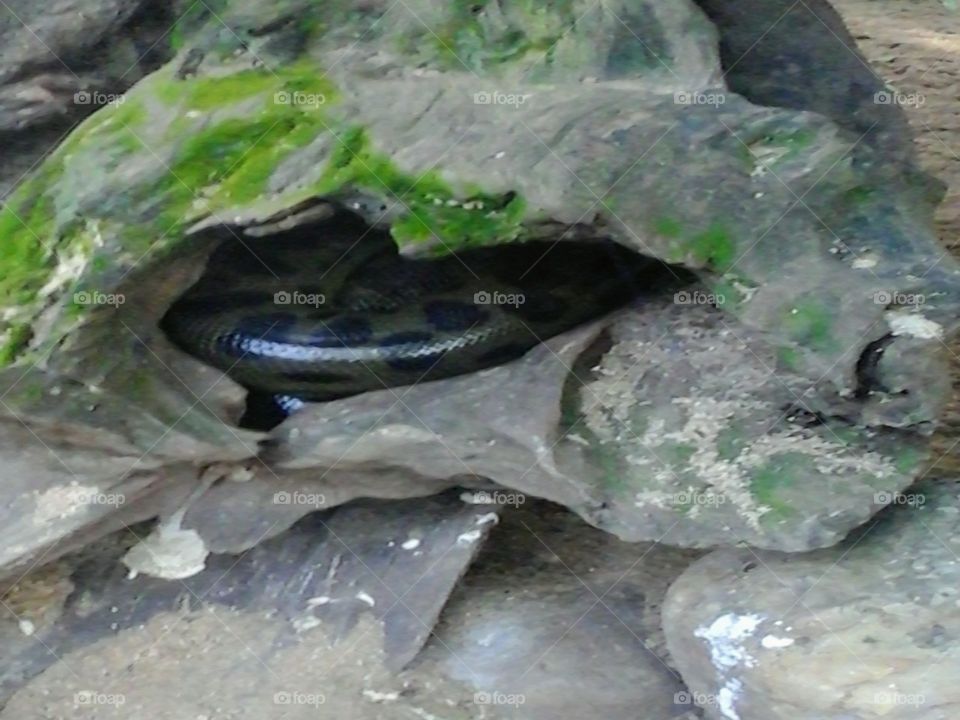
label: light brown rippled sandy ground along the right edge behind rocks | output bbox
[825,0,960,473]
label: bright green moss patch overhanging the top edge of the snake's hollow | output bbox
[313,127,526,250]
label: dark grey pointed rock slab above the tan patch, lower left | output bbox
[0,494,498,704]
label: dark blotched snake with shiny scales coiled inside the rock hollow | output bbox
[160,208,659,429]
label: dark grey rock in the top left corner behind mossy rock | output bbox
[0,0,174,197]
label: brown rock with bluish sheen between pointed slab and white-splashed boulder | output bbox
[417,501,699,720]
